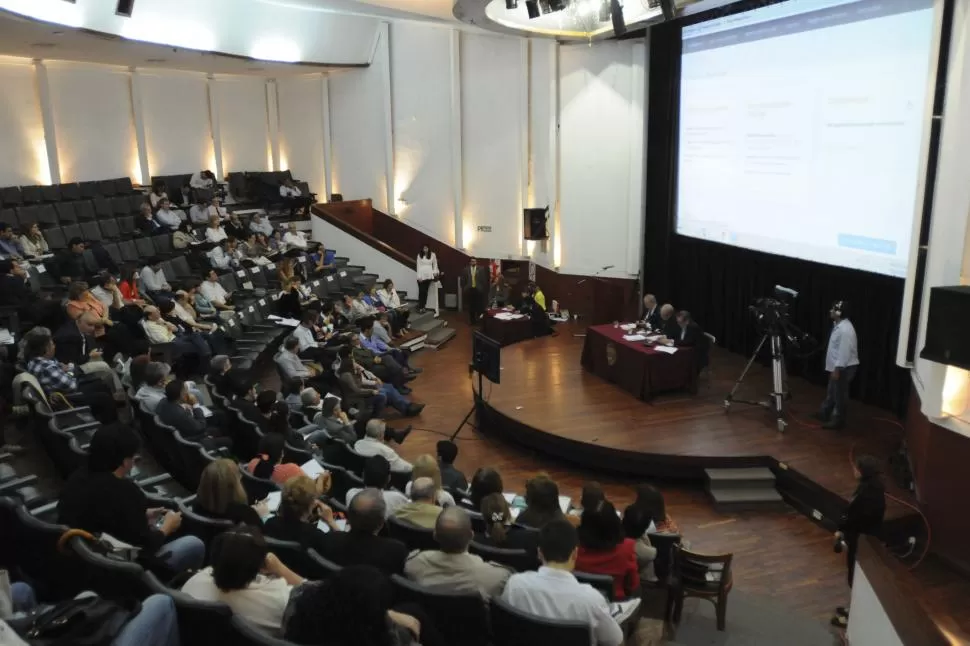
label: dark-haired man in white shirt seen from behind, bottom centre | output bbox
[502,518,640,646]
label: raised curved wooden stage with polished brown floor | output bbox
[478,324,911,525]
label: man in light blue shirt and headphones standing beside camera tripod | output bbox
[815,301,859,429]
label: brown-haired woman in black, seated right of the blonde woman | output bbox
[265,475,341,554]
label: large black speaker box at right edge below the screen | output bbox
[911,285,970,370]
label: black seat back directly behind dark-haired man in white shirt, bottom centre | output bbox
[489,597,593,646]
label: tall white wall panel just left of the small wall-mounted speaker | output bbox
[461,34,528,257]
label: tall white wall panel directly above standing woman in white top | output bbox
[390,22,456,245]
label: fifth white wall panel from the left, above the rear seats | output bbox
[276,74,325,195]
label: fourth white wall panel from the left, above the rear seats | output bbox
[212,76,272,174]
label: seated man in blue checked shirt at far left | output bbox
[24,333,118,424]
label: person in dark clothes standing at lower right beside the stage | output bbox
[832,455,886,628]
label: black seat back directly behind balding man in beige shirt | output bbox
[391,574,488,646]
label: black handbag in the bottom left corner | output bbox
[18,596,141,646]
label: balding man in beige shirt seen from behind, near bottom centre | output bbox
[404,506,512,600]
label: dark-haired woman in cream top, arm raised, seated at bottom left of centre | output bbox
[182,525,303,636]
